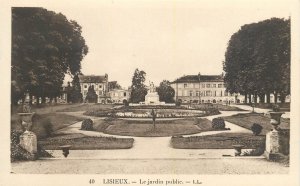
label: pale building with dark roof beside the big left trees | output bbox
[78,74,109,103]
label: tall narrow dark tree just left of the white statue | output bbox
[130,69,147,103]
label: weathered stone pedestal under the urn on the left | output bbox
[20,131,37,154]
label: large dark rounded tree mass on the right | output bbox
[223,18,290,103]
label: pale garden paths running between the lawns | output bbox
[52,111,251,159]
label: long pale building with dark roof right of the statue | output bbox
[171,73,244,104]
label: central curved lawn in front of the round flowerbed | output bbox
[94,118,217,137]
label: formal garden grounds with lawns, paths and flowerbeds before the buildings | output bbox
[11,101,289,174]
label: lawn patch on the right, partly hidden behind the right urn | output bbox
[223,113,290,135]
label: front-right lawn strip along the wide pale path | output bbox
[171,133,265,149]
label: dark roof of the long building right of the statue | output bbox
[172,75,224,83]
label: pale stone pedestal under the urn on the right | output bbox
[265,130,281,160]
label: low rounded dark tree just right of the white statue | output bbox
[156,80,175,103]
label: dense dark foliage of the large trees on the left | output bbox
[11,7,88,104]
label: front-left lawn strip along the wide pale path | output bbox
[38,134,134,150]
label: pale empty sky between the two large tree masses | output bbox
[38,0,290,87]
